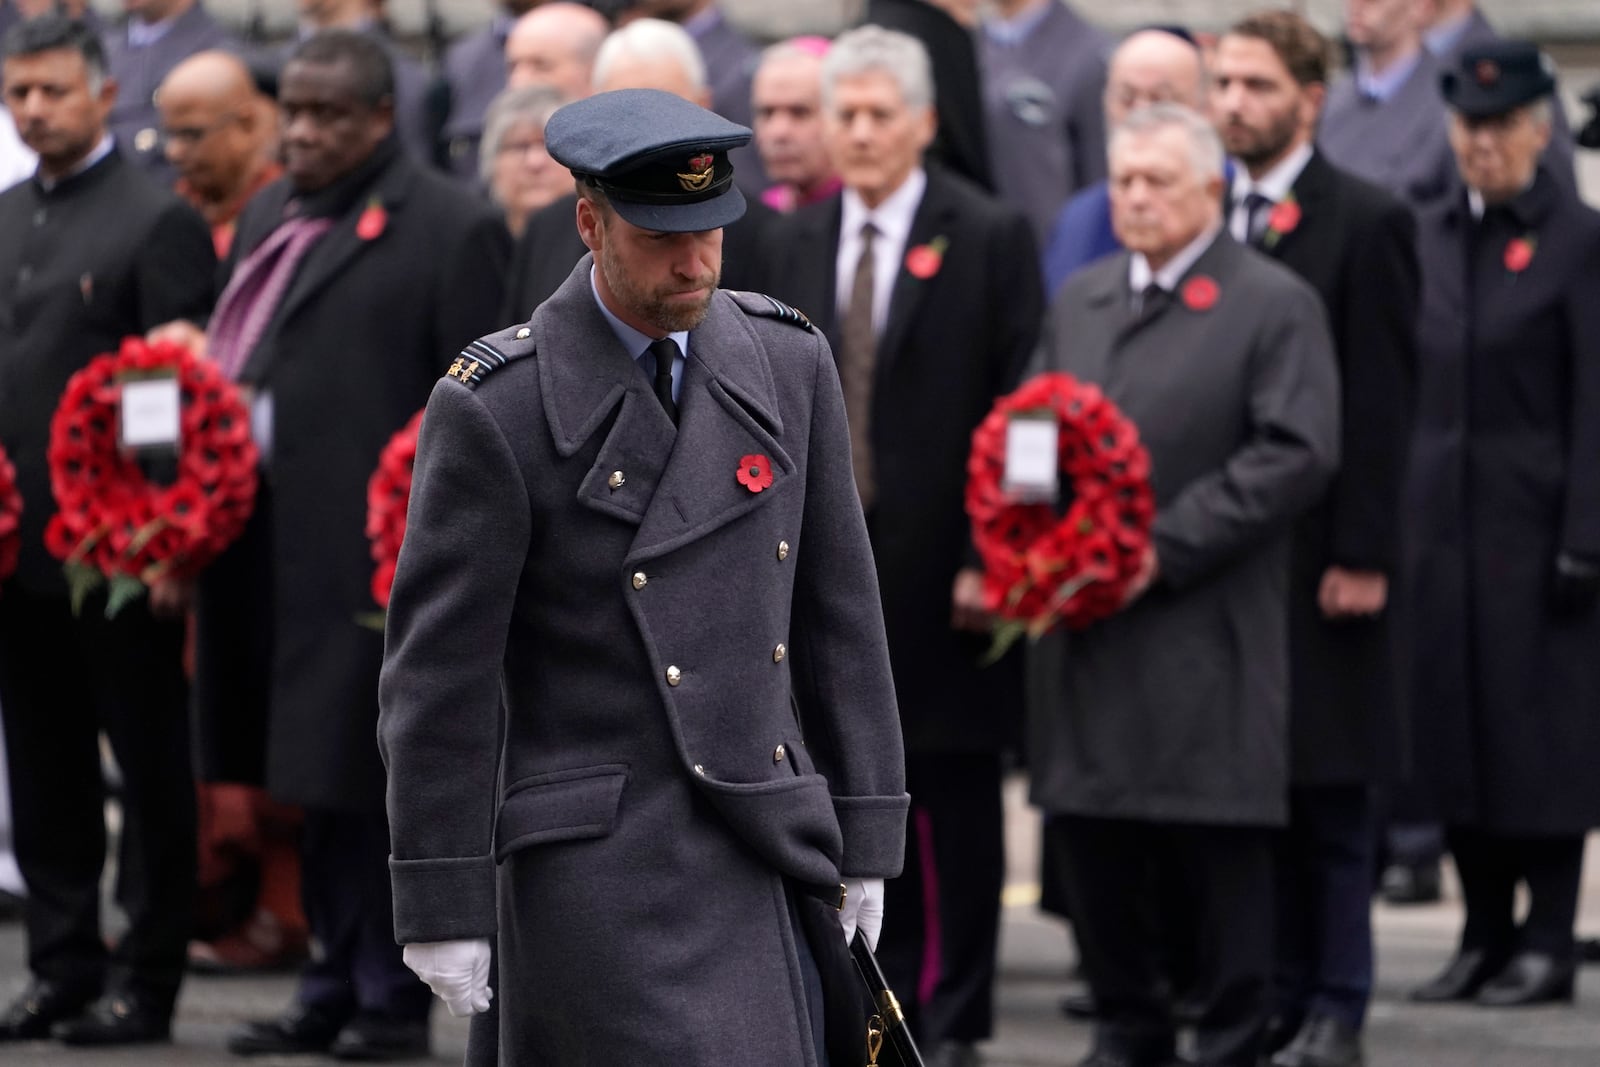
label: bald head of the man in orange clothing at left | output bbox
[155,51,277,202]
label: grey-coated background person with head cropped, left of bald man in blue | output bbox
[978,0,1112,245]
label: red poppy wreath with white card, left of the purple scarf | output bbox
[45,338,256,617]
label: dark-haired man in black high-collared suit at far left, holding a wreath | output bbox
[0,14,216,1043]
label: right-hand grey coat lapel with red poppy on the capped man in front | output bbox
[613,287,798,565]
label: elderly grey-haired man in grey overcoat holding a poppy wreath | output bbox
[1024,104,1339,1067]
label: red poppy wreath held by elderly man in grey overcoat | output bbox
[966,373,1155,657]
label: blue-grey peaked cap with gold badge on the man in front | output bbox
[544,90,750,234]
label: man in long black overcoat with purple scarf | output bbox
[198,30,507,1059]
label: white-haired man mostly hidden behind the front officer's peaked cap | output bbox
[501,19,774,322]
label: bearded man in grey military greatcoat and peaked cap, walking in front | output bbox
[369,90,907,1067]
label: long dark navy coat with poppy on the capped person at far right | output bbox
[1406,168,1600,835]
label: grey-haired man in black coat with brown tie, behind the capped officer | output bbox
[771,26,1043,1064]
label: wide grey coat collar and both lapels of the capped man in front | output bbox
[530,256,797,563]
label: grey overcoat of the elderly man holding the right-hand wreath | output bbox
[1027,234,1339,825]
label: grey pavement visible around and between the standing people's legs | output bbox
[0,781,1600,1067]
